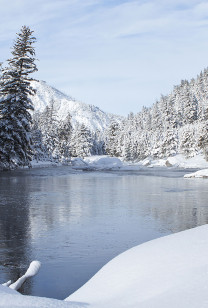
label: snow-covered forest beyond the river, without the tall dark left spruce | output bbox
[34,69,208,161]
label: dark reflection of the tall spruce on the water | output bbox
[0,177,31,293]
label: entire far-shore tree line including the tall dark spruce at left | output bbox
[0,26,208,169]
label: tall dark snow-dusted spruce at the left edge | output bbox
[0,26,37,169]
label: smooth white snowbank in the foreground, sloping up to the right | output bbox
[0,225,208,308]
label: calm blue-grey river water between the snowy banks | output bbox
[0,167,208,299]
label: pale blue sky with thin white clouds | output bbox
[0,0,208,115]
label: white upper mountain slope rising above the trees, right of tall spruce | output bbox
[31,81,121,131]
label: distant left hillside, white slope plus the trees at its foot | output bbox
[31,81,122,162]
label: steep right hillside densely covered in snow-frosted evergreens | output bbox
[106,69,208,161]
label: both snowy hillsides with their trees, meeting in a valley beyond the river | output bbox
[29,69,208,161]
